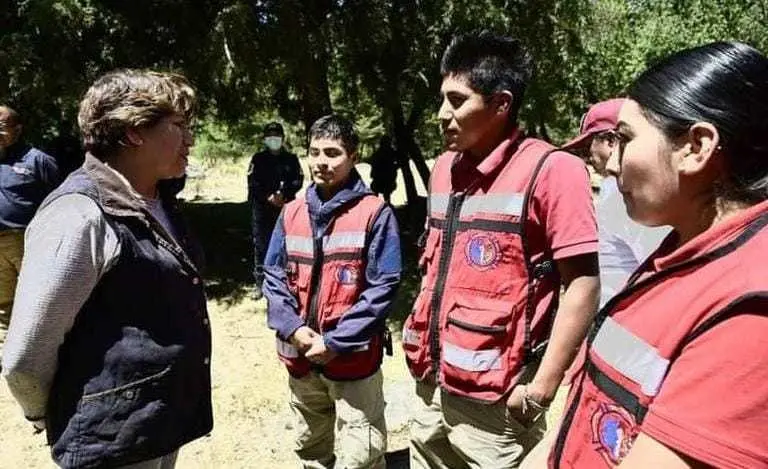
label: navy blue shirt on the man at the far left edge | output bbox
[0,142,61,230]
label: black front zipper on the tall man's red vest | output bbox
[429,192,464,376]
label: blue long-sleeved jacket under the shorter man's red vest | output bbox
[264,170,401,354]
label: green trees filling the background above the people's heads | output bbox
[0,0,768,190]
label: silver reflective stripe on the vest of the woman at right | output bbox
[592,317,669,396]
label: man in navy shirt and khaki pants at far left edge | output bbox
[0,106,61,362]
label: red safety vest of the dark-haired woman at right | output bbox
[549,210,768,469]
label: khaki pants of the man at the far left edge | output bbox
[0,230,24,357]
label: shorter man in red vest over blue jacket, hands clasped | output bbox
[264,115,401,469]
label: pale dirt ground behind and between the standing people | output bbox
[0,160,562,469]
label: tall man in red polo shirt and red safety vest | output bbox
[403,32,599,469]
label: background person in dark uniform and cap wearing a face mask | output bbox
[248,122,304,300]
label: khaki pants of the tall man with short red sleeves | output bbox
[410,382,546,469]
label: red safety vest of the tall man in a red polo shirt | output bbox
[403,139,559,402]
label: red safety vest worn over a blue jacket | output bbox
[277,195,385,380]
